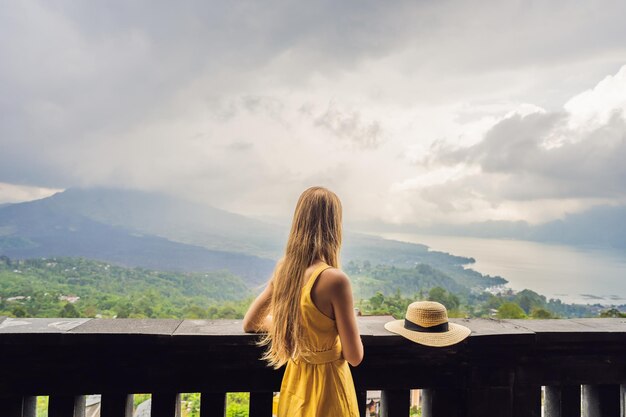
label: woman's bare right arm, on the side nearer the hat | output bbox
[329,269,363,366]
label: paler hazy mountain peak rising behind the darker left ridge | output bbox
[40,188,287,258]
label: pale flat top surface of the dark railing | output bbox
[0,316,626,344]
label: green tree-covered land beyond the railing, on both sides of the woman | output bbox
[0,256,626,319]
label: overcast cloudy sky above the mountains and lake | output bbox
[0,0,626,225]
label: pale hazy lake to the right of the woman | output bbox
[378,233,626,305]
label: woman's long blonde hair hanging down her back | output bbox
[260,187,342,368]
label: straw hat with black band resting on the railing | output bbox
[385,301,472,347]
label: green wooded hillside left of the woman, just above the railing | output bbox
[0,257,251,318]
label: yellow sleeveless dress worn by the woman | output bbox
[278,264,359,417]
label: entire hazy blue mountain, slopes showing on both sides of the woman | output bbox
[0,188,505,288]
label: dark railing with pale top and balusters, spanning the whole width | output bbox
[0,317,626,417]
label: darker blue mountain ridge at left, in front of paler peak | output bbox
[0,196,274,284]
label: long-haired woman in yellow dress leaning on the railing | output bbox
[243,187,363,417]
